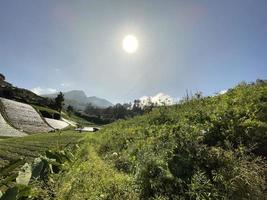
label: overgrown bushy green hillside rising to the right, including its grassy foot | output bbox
[58,81,267,200]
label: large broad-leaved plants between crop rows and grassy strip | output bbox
[1,145,80,200]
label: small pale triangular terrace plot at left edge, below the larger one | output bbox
[0,113,27,137]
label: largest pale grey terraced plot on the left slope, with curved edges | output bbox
[0,98,53,133]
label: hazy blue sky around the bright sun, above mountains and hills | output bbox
[0,0,267,103]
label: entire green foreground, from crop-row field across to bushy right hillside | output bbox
[0,81,267,200]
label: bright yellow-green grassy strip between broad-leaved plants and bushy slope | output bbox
[57,134,138,200]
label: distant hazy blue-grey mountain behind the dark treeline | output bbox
[42,90,113,110]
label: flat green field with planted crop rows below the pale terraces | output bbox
[0,130,85,193]
